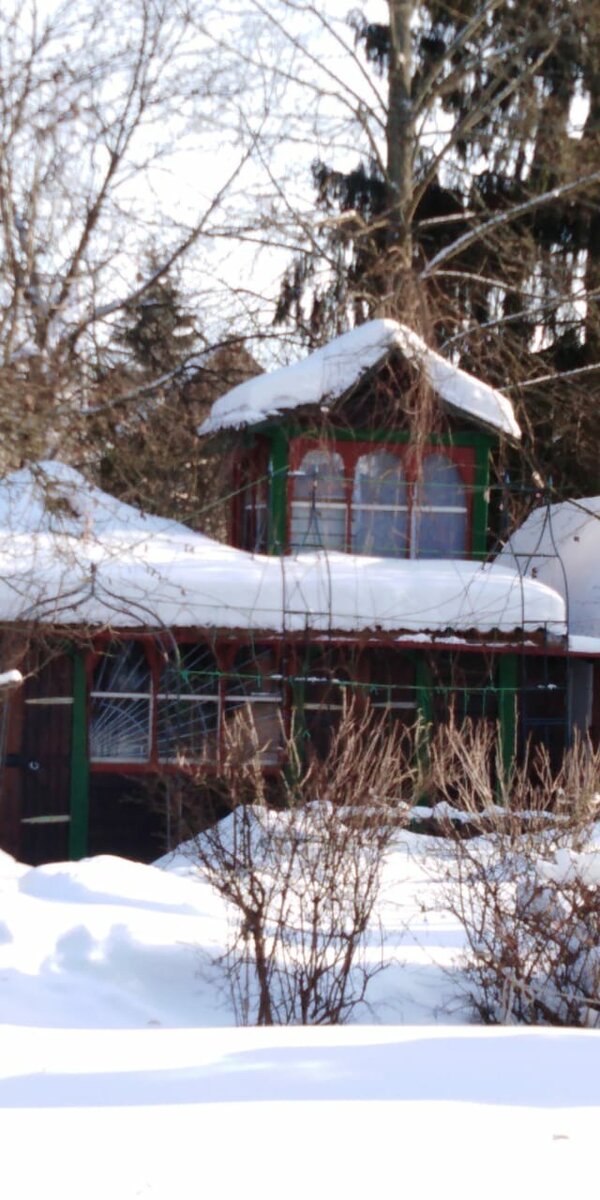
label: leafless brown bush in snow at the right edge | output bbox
[444,744,600,1027]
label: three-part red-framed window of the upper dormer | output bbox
[289,439,474,558]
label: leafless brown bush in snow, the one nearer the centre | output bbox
[184,706,420,1025]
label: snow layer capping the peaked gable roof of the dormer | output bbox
[198,320,521,438]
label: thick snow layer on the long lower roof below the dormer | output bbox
[0,463,565,635]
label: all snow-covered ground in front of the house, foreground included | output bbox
[0,833,600,1200]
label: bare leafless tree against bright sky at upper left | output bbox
[0,0,253,466]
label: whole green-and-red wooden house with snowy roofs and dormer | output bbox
[0,322,576,862]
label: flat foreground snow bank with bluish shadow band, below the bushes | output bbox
[0,1027,600,1200]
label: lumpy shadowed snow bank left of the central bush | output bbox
[0,856,232,1028]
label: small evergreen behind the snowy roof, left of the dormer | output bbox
[90,275,258,539]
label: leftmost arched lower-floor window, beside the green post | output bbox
[90,642,151,762]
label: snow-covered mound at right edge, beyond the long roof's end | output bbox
[497,496,600,644]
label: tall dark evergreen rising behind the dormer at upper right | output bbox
[276,0,600,492]
